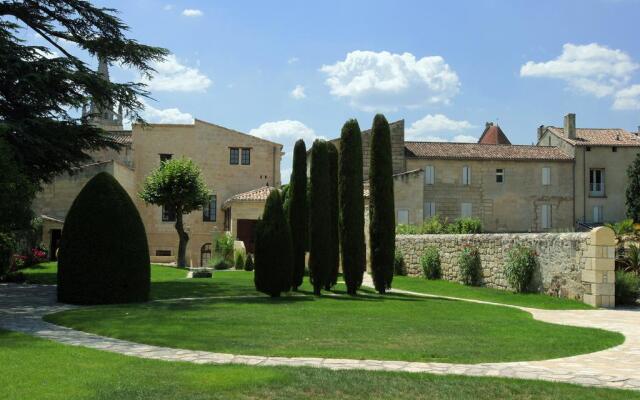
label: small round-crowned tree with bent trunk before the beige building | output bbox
[140,158,209,268]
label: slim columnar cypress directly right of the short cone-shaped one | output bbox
[288,139,309,290]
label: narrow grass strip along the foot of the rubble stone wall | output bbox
[392,276,593,310]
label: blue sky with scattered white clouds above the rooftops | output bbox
[32,0,640,181]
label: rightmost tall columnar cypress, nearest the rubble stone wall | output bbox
[369,114,395,294]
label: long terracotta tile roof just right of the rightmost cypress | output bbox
[404,142,573,161]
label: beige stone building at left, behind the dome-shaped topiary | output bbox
[33,58,283,266]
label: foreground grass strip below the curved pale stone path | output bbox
[0,331,640,400]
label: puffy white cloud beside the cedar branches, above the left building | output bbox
[142,54,212,92]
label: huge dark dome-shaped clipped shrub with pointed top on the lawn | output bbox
[58,172,150,304]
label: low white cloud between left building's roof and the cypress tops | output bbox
[249,119,323,183]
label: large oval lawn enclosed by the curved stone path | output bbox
[46,272,623,363]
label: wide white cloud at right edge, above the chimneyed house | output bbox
[520,43,640,97]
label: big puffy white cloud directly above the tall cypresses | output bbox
[320,50,460,111]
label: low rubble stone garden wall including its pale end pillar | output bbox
[396,227,615,307]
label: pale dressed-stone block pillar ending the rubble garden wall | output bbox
[582,226,616,308]
